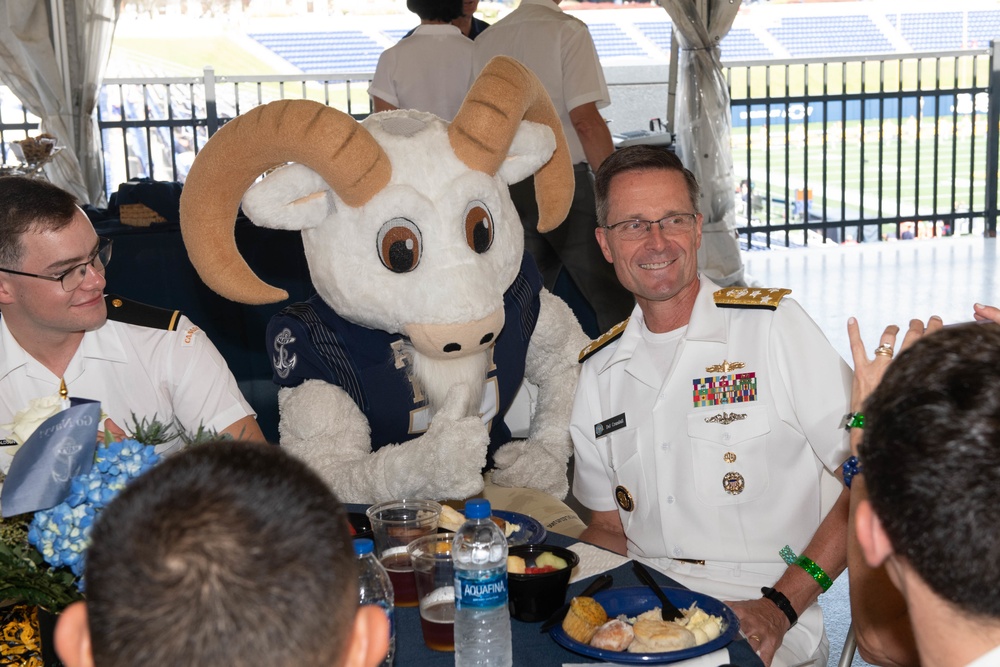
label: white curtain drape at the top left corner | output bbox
[0,0,118,205]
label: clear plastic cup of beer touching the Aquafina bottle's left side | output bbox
[407,533,455,651]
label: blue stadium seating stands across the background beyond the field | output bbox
[250,3,1000,73]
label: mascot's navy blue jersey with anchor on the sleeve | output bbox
[267,253,542,469]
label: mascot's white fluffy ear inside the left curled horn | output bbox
[243,164,336,230]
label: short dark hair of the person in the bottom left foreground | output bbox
[85,442,358,667]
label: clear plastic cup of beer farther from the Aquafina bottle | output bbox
[366,499,441,607]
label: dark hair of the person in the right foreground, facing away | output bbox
[860,323,1000,618]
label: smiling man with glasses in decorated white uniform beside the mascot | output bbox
[571,146,851,665]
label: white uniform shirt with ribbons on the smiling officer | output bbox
[571,276,852,667]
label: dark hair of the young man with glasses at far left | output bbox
[0,176,77,269]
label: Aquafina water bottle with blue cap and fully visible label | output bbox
[451,499,512,667]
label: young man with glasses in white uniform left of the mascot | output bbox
[0,177,264,460]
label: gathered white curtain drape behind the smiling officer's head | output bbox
[658,0,745,285]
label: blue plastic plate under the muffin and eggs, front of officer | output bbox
[549,586,740,665]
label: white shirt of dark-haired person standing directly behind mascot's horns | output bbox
[368,24,473,121]
